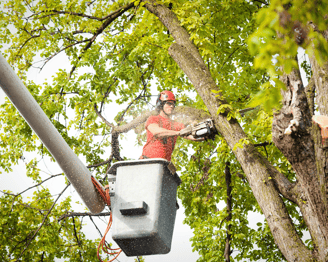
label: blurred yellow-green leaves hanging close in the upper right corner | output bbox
[248,0,328,112]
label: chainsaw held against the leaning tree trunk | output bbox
[179,119,218,140]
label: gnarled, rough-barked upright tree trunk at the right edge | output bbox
[272,66,328,261]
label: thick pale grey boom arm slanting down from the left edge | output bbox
[0,54,105,213]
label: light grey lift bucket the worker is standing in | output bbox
[109,158,181,256]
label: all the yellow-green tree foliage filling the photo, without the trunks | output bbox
[0,0,322,261]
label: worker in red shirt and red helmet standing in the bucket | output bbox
[140,91,204,161]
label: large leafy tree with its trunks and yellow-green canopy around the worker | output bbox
[0,0,328,261]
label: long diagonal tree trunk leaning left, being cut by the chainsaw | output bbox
[144,0,313,261]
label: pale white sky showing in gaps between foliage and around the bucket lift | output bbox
[0,51,199,262]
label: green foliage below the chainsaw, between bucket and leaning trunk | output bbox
[175,130,290,262]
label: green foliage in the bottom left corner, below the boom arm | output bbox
[0,188,98,261]
